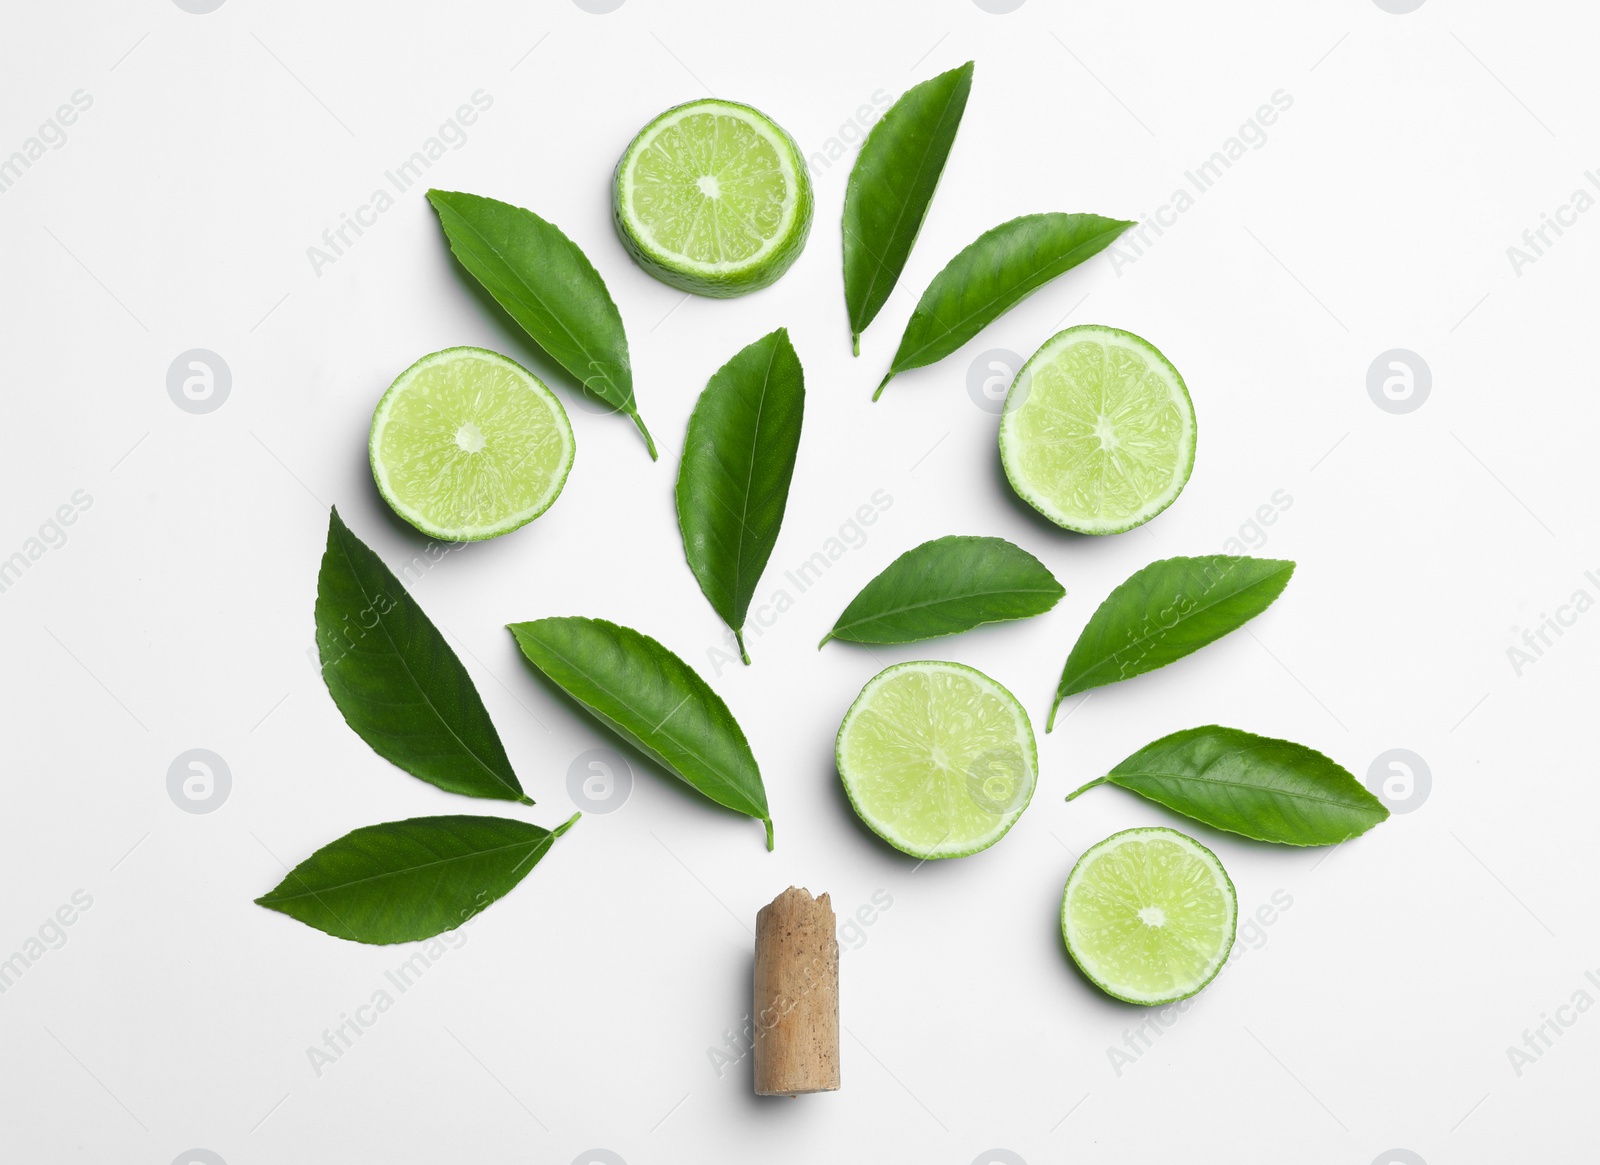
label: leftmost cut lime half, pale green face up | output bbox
[368,347,573,542]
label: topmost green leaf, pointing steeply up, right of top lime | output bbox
[843,61,973,355]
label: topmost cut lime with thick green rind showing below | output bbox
[611,98,811,296]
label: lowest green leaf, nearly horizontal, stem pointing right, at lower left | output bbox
[256,813,579,944]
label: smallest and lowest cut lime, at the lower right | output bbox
[1061,829,1238,1005]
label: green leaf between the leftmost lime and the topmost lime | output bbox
[427,190,656,459]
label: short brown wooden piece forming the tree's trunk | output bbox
[754,887,838,1096]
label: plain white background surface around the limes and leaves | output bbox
[0,0,1600,1165]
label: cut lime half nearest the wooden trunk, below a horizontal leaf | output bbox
[835,661,1038,858]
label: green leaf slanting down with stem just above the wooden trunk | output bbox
[510,616,773,850]
